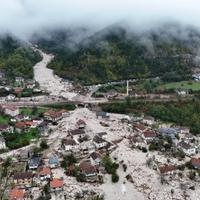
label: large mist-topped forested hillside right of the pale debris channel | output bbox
[35,27,200,84]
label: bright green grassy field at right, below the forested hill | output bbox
[157,81,200,91]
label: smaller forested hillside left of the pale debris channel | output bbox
[0,36,41,79]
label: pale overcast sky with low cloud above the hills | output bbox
[0,0,200,38]
